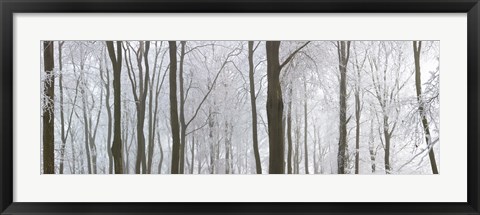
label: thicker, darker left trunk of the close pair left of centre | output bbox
[168,41,180,174]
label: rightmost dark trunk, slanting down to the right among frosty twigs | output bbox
[413,41,438,174]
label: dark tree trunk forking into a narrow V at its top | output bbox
[106,41,123,174]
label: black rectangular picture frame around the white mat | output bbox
[0,0,480,214]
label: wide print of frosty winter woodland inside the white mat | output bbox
[39,40,440,177]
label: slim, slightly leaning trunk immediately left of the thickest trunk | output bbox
[248,41,262,174]
